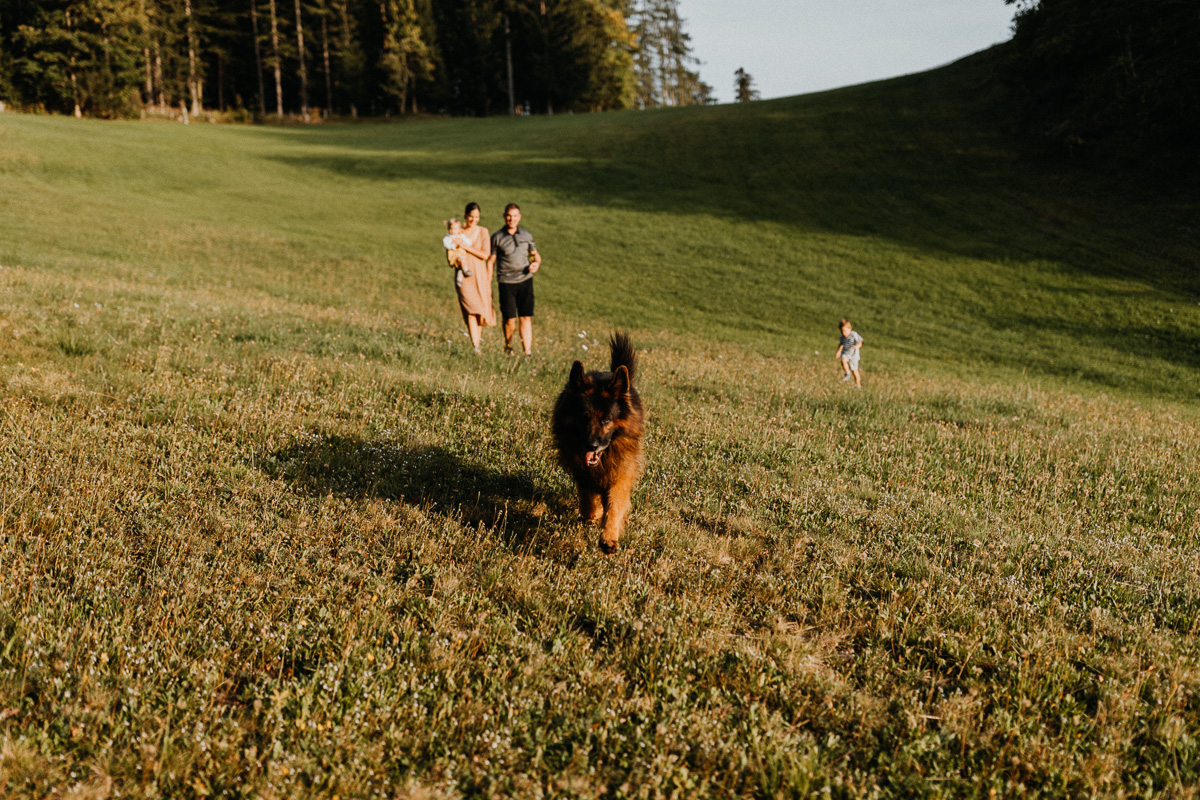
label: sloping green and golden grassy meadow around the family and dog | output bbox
[0,48,1200,800]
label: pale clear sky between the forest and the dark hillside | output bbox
[679,0,1015,103]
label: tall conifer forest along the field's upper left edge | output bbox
[0,0,712,119]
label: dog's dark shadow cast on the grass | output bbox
[266,435,570,554]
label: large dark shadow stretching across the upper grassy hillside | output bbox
[255,53,1200,300]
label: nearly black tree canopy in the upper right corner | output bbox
[1006,0,1200,146]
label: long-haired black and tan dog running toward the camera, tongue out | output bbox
[551,332,646,553]
